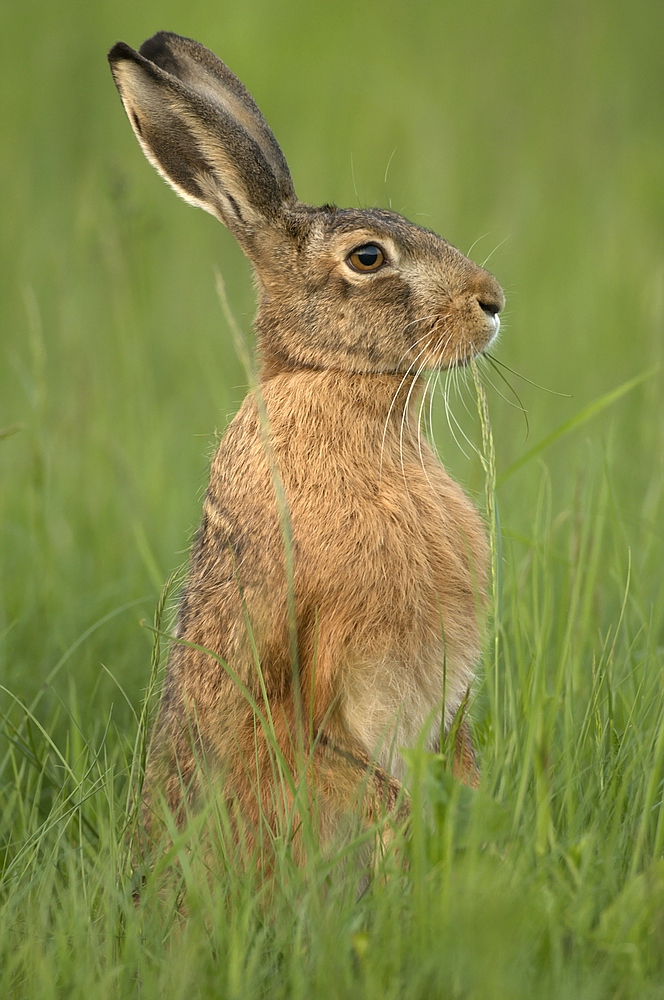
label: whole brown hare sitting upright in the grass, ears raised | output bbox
[109,32,504,856]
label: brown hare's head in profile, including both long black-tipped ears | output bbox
[109,32,504,373]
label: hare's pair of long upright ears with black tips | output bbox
[108,31,296,243]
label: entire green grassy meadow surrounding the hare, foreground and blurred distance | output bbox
[0,0,664,1000]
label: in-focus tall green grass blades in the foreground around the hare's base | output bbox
[0,380,664,998]
